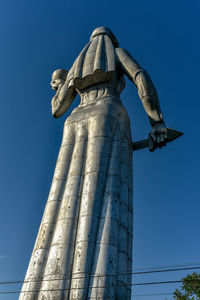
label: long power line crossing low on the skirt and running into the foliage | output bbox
[0,279,200,295]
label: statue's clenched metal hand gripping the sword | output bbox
[149,123,167,151]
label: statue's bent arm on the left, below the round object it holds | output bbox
[51,82,77,118]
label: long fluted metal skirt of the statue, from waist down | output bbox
[20,87,133,300]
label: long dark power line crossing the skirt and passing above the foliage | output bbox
[0,266,200,285]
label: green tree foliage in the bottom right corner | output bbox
[173,273,200,300]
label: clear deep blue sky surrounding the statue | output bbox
[0,0,200,300]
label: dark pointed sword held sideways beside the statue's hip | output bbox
[132,128,184,151]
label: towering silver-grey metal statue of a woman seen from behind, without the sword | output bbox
[19,27,167,300]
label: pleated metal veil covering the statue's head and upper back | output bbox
[67,26,119,90]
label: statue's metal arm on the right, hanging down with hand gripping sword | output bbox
[116,48,167,147]
